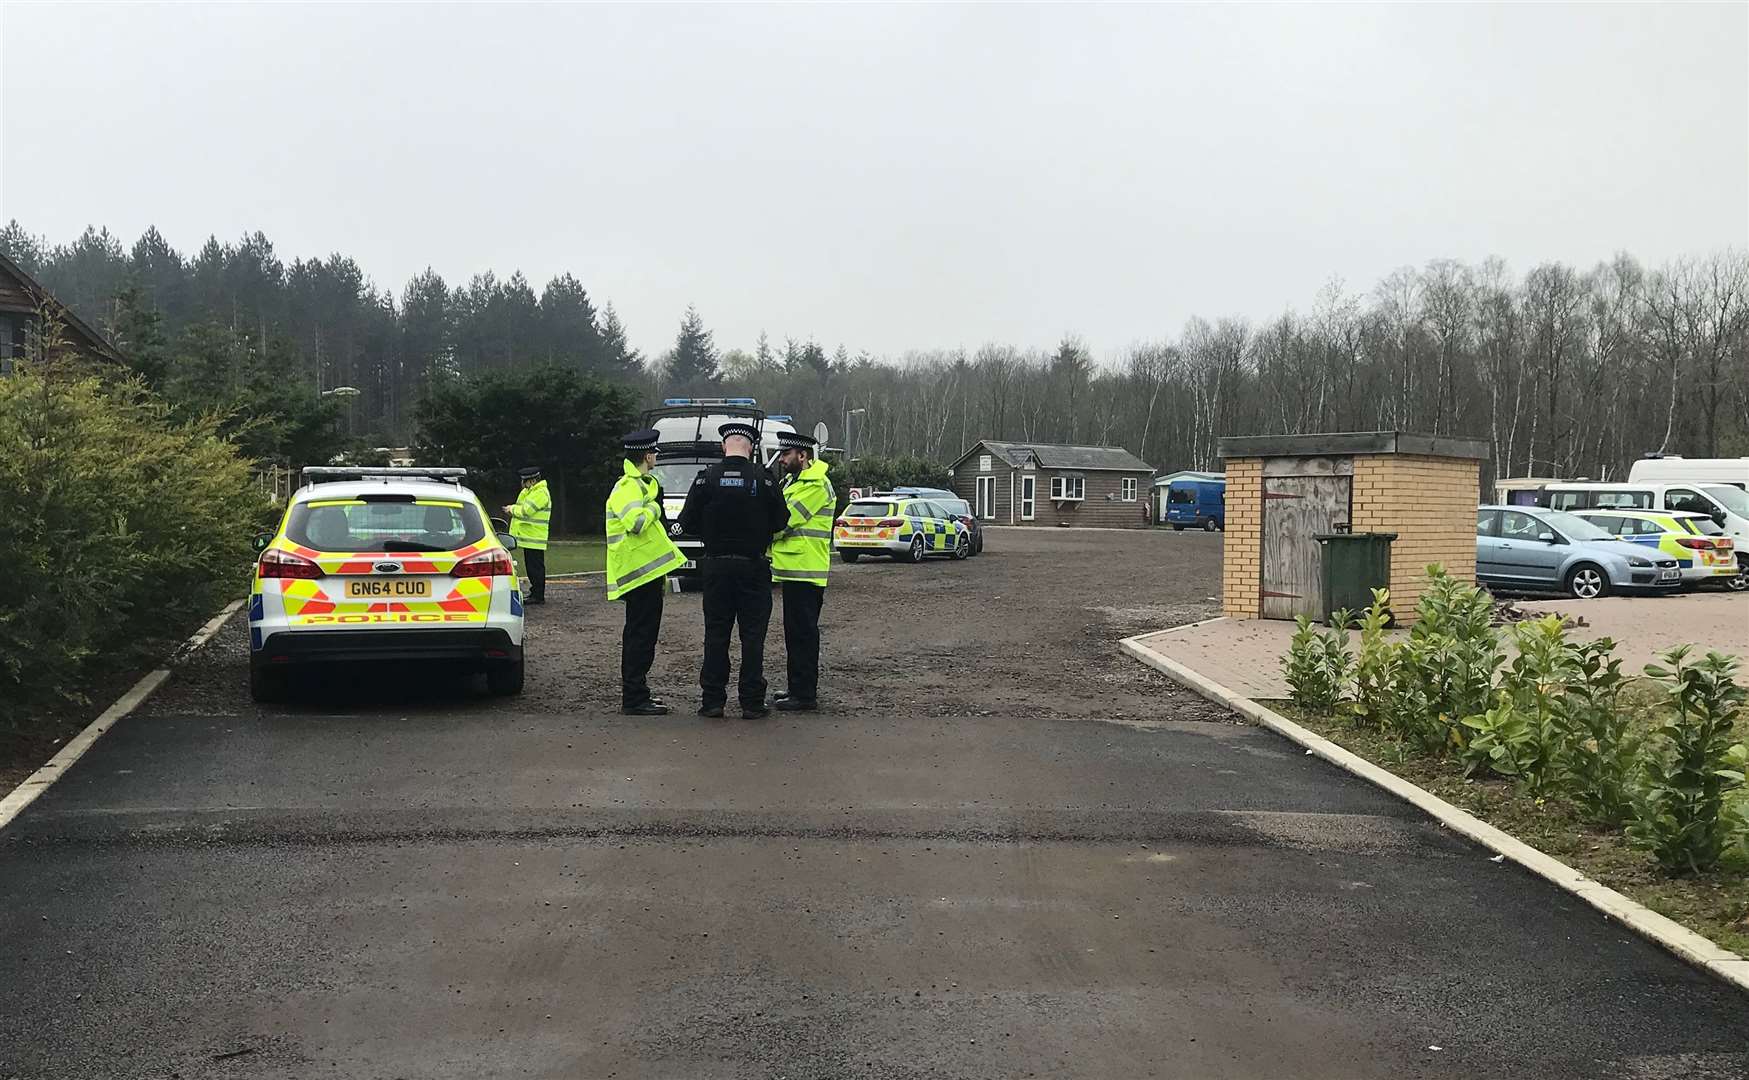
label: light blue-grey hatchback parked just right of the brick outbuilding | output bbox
[1476,506,1683,600]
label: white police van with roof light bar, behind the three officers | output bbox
[644,397,796,579]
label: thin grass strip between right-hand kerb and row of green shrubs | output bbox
[1265,703,1749,956]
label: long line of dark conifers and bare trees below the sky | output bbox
[0,222,1749,476]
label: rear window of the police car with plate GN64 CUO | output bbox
[285,497,486,551]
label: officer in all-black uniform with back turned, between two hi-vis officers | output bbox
[680,422,789,719]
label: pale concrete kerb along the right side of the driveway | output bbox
[1119,620,1749,992]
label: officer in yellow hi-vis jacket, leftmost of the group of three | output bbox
[607,429,686,716]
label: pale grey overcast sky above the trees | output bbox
[0,0,1749,357]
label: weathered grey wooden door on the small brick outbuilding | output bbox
[1261,459,1354,620]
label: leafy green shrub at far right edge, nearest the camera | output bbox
[1628,646,1746,873]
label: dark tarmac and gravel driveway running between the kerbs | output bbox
[0,530,1749,1080]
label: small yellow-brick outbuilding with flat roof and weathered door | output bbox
[1221,431,1488,621]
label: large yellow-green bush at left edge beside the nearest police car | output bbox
[0,364,268,728]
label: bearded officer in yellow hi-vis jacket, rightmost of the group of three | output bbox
[771,431,838,712]
